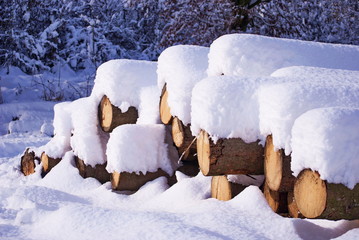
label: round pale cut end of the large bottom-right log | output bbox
[294,169,327,218]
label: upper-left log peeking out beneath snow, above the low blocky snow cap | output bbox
[98,96,138,132]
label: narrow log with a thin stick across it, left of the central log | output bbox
[172,117,197,161]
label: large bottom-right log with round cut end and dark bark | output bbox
[294,169,359,220]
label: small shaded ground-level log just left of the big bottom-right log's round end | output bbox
[263,183,288,214]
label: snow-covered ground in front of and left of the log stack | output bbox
[0,34,359,240]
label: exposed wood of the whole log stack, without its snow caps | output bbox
[21,85,359,220]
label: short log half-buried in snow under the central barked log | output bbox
[211,175,246,201]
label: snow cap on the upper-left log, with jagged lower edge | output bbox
[91,59,159,112]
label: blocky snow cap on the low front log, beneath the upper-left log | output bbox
[106,124,176,176]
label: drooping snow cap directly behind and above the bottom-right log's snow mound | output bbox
[258,68,359,155]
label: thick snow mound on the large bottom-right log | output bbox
[291,108,359,188]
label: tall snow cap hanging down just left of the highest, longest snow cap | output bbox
[157,45,209,125]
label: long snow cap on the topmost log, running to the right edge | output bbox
[208,34,359,76]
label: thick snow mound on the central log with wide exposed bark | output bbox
[191,76,272,143]
